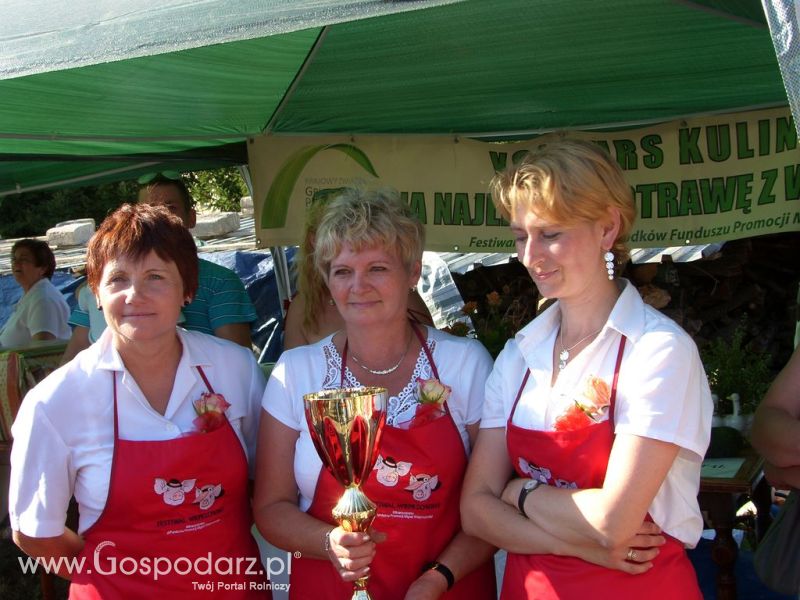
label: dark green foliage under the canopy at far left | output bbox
[0,181,137,238]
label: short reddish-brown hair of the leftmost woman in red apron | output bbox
[86,204,198,298]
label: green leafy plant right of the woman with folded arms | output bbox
[700,319,773,414]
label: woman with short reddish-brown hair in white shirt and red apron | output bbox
[9,204,269,599]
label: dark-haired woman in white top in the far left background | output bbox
[0,239,71,348]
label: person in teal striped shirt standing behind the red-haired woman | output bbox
[61,174,257,364]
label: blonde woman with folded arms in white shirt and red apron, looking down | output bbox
[462,140,712,599]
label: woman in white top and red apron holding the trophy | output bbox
[254,190,496,600]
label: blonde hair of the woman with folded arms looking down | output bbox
[491,139,636,264]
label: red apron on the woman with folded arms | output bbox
[500,336,702,600]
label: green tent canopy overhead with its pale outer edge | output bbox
[0,0,787,196]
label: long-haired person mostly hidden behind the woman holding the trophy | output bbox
[283,201,433,350]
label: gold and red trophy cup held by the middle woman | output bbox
[303,387,389,600]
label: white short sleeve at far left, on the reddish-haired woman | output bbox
[8,395,75,537]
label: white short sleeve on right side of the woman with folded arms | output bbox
[616,331,713,461]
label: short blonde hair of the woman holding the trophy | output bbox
[314,188,425,278]
